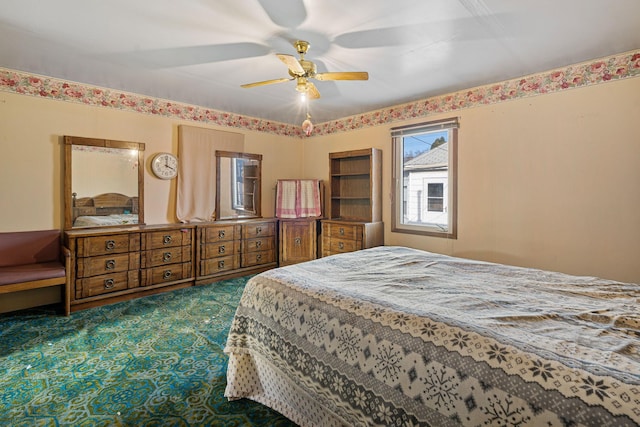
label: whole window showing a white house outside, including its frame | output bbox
[391,118,458,239]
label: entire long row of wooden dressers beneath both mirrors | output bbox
[64,218,278,311]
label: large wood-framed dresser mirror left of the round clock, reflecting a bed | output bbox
[64,136,144,229]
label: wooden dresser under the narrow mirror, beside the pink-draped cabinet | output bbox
[196,218,278,284]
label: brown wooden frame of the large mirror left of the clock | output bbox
[63,136,145,230]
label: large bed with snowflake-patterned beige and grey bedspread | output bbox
[225,246,640,427]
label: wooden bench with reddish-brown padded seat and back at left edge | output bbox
[0,230,71,316]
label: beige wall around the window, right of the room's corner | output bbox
[304,78,640,283]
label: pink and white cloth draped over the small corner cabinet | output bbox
[276,179,322,218]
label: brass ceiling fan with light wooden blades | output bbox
[241,40,369,99]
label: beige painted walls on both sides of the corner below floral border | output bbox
[0,78,640,311]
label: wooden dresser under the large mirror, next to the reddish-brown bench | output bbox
[64,224,195,311]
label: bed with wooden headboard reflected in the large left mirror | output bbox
[72,193,138,227]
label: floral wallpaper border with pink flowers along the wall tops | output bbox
[0,50,640,138]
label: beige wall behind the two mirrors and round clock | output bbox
[0,92,303,312]
